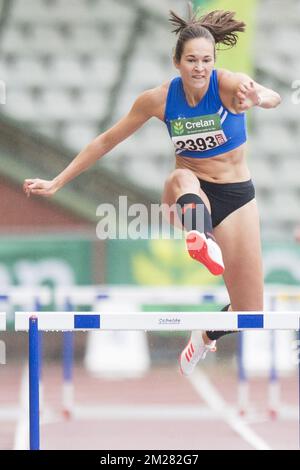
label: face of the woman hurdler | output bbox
[174,38,215,89]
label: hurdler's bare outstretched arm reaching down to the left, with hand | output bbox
[23,87,162,196]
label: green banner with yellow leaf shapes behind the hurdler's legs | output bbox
[106,240,300,286]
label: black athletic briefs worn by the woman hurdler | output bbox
[198,178,255,228]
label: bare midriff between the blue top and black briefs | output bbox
[176,143,251,183]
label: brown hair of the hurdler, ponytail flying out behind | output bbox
[169,3,246,63]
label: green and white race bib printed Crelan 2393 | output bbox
[170,114,227,153]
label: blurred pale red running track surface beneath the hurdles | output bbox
[0,365,299,450]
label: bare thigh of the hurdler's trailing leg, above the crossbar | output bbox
[214,199,263,311]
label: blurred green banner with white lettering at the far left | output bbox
[0,235,92,327]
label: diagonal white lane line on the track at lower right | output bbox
[189,369,271,450]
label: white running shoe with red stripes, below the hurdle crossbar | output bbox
[179,331,217,375]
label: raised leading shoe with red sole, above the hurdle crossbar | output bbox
[186,230,225,276]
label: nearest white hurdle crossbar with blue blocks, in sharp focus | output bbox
[15,311,300,331]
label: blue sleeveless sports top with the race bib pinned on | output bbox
[164,70,247,158]
